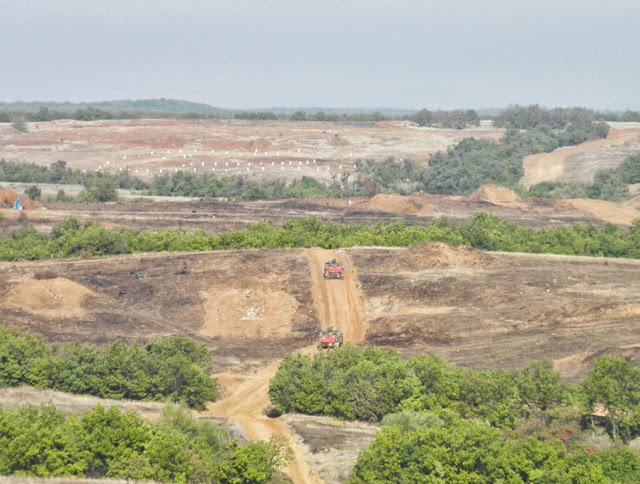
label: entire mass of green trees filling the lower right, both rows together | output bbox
[269,345,640,483]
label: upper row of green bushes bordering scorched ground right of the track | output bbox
[269,345,640,441]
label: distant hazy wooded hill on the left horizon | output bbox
[0,98,230,115]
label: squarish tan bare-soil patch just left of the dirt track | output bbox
[198,288,299,338]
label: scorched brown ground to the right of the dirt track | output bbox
[350,248,640,381]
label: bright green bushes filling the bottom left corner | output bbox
[0,405,286,483]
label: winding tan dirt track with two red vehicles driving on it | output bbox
[204,249,365,483]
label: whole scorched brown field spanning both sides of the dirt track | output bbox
[0,248,640,380]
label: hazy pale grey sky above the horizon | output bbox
[0,0,640,109]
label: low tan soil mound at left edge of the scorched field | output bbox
[2,277,94,318]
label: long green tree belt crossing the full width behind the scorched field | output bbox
[0,212,640,261]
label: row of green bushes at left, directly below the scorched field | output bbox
[0,327,218,410]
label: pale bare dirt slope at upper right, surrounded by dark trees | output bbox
[520,128,640,187]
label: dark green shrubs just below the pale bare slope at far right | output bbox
[528,155,640,202]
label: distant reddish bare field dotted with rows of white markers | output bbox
[0,120,502,180]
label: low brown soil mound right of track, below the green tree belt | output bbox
[382,242,495,271]
